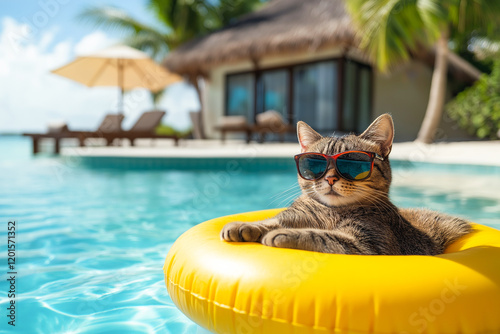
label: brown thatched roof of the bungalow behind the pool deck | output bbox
[164,0,355,74]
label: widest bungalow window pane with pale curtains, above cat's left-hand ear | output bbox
[293,61,338,132]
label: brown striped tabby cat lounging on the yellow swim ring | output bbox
[221,114,471,255]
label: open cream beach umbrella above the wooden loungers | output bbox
[51,45,182,113]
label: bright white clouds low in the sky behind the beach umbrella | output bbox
[0,17,199,132]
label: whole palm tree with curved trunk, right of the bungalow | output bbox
[347,0,500,143]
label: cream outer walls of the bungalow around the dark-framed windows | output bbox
[204,48,471,141]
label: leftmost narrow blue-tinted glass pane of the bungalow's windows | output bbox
[226,73,254,121]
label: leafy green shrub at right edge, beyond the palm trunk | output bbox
[446,60,500,139]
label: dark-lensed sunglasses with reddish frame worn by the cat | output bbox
[294,151,384,181]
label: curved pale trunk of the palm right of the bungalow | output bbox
[415,32,448,144]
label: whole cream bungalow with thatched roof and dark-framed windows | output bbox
[164,0,479,141]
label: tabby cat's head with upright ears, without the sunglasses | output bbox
[297,114,394,207]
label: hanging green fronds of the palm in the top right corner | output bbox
[346,0,500,70]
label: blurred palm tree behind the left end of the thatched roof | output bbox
[80,0,266,135]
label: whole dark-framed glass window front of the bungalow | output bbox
[226,58,372,134]
